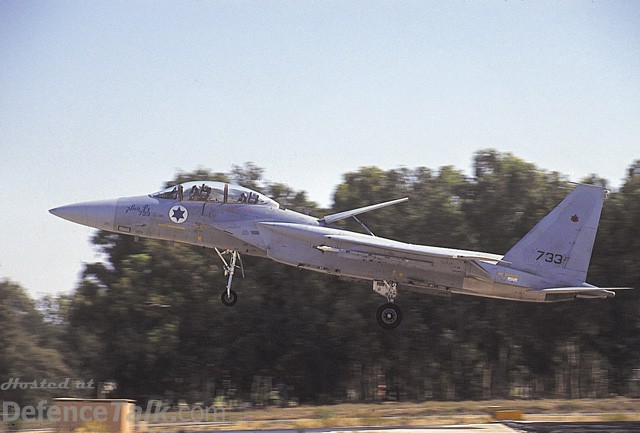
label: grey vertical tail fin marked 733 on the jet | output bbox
[503,184,606,287]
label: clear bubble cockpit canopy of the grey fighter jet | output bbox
[151,181,280,208]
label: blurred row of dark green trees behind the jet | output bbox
[0,150,640,404]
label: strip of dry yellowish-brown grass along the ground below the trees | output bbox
[152,397,640,431]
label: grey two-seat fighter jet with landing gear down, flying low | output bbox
[50,181,615,329]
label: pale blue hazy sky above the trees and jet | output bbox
[0,0,640,297]
